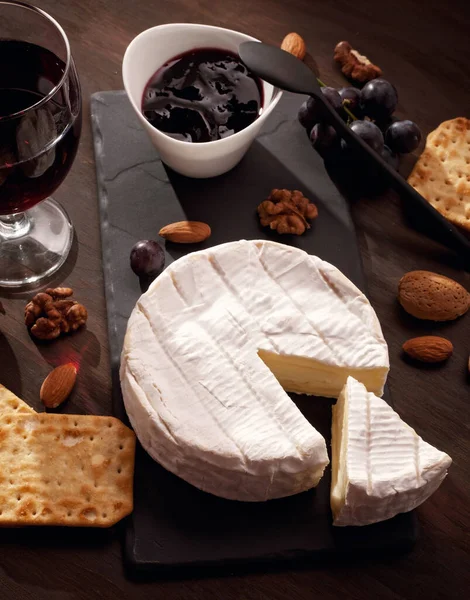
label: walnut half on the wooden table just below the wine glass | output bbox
[24,288,88,340]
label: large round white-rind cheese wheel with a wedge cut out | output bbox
[121,240,389,501]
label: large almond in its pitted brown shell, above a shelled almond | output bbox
[398,271,470,321]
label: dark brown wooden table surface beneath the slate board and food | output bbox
[0,0,470,600]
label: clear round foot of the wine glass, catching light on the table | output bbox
[0,198,73,288]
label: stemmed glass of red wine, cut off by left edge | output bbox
[0,0,82,287]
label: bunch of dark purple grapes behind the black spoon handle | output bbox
[298,79,421,169]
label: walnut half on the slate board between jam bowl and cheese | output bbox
[258,189,318,235]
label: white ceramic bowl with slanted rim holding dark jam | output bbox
[122,23,282,178]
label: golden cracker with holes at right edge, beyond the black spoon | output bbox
[408,117,470,231]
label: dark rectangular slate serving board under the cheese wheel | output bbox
[91,91,417,576]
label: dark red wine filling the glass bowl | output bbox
[0,40,81,215]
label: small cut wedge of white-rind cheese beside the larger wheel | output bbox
[331,377,452,525]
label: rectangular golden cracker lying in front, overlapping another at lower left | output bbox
[0,413,135,527]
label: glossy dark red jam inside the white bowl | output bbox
[142,48,263,142]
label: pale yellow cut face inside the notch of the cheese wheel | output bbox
[258,350,388,398]
